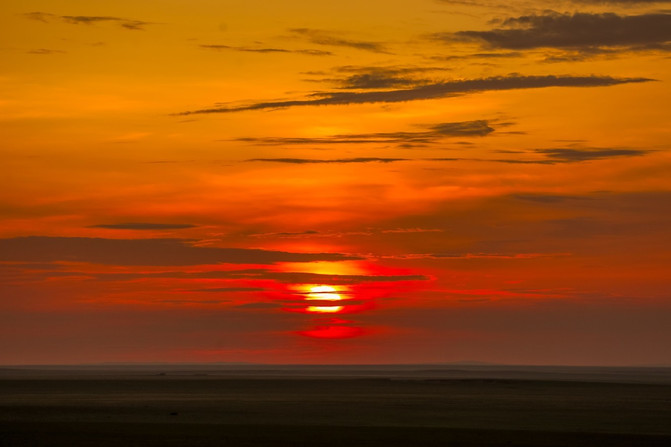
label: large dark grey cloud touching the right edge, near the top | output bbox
[432,11,671,51]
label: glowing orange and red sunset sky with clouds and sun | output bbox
[0,0,671,365]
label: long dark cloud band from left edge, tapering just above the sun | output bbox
[0,236,360,266]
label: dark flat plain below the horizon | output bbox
[0,367,671,447]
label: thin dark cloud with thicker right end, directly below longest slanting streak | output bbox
[236,120,494,146]
